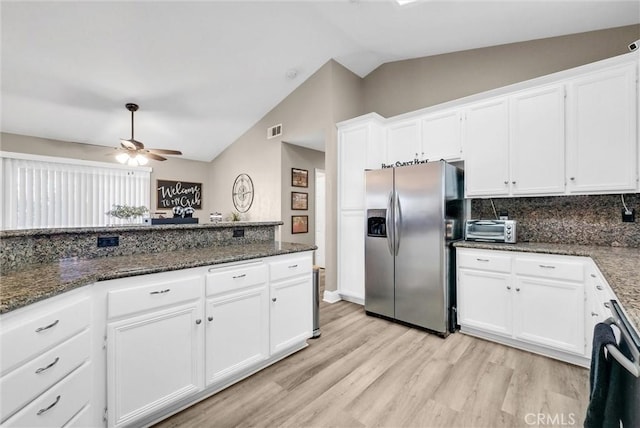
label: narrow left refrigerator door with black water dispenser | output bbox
[363,168,394,318]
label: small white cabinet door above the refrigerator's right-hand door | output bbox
[422,111,462,161]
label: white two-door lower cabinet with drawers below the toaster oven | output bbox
[457,248,589,365]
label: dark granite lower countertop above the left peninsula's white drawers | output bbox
[0,242,316,314]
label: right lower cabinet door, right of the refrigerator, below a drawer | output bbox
[514,277,584,355]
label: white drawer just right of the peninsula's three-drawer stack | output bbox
[107,275,203,318]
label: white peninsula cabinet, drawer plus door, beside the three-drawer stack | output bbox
[107,274,205,426]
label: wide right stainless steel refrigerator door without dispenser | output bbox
[395,162,448,334]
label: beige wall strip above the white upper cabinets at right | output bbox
[363,25,640,117]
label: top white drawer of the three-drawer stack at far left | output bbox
[0,298,91,373]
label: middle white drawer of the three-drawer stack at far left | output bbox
[0,330,91,420]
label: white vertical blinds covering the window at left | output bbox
[0,152,151,230]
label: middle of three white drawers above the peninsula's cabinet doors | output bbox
[207,262,267,296]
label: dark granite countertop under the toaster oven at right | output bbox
[454,241,640,331]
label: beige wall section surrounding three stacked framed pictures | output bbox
[280,143,324,245]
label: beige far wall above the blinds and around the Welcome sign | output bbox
[0,133,211,219]
